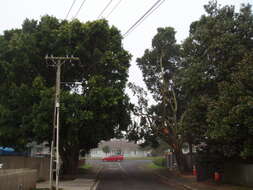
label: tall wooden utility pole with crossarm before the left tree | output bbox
[45,56,79,190]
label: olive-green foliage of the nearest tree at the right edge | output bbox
[208,52,253,158]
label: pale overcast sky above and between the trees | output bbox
[0,0,253,104]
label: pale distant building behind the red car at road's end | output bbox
[90,139,150,158]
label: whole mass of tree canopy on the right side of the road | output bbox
[130,1,253,172]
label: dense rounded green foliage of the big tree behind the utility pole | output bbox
[0,16,131,173]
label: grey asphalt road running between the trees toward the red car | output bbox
[89,160,181,190]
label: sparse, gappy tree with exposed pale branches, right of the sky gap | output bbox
[133,27,182,141]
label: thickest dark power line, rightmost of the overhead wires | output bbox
[123,0,165,37]
